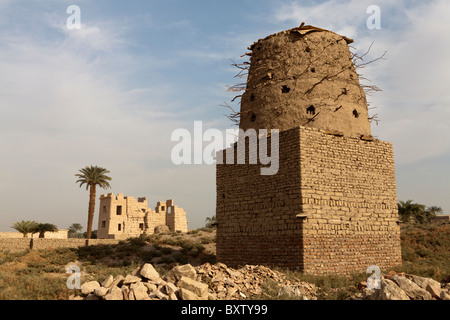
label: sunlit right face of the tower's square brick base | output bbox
[300,128,401,273]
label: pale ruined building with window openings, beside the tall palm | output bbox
[97,193,188,239]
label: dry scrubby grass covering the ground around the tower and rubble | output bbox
[0,223,450,300]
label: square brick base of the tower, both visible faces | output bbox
[216,127,401,274]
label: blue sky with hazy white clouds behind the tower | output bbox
[0,0,450,231]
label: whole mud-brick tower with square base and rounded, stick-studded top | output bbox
[216,26,401,274]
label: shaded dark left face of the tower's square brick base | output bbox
[216,129,302,268]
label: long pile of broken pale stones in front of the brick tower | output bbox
[70,263,316,300]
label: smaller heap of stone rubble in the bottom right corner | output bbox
[358,271,450,300]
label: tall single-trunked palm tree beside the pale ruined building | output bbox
[75,166,111,245]
